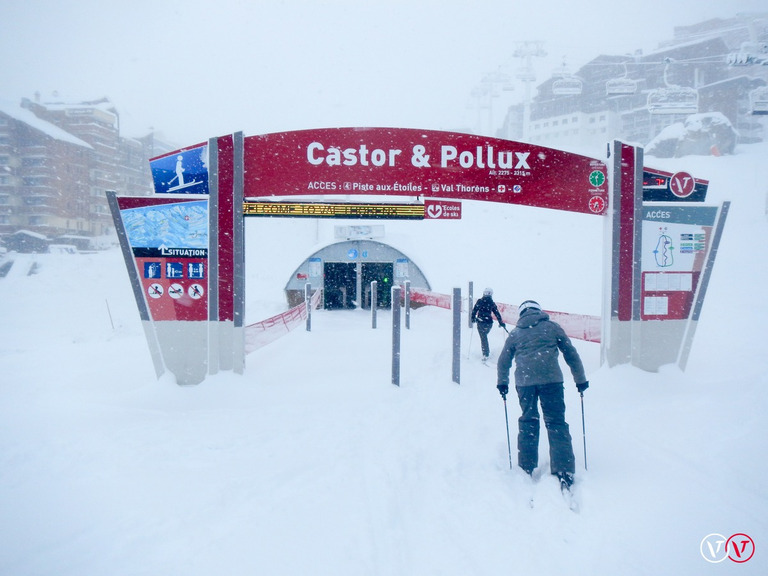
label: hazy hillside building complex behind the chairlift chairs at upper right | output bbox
[499,13,768,148]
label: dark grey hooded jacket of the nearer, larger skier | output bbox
[497,309,587,387]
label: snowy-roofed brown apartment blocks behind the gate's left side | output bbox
[0,97,165,249]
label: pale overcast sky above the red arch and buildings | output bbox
[0,0,768,145]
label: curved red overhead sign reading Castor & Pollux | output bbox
[244,128,608,214]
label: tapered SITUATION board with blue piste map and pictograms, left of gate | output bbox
[107,192,209,384]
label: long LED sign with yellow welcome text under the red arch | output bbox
[243,202,424,220]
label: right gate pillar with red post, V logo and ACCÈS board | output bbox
[601,142,727,371]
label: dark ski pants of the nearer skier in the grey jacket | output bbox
[516,382,576,475]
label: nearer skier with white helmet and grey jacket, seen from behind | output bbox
[496,300,589,490]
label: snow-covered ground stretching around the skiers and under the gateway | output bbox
[0,145,768,576]
